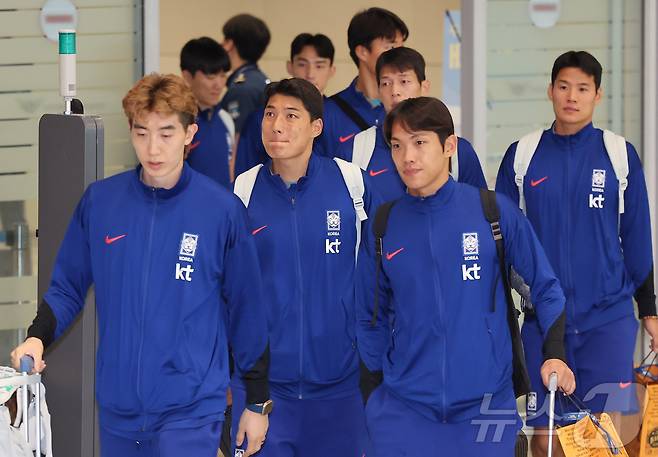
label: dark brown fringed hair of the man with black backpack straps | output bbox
[384,97,455,146]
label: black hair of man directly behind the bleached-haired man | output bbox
[180,36,231,76]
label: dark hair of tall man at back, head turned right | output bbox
[347,7,409,67]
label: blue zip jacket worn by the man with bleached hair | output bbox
[44,165,267,434]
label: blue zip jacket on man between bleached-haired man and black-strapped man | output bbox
[234,153,379,399]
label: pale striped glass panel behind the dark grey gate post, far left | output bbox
[0,0,142,365]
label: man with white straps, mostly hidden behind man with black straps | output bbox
[336,47,487,201]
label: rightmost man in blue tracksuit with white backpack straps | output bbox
[496,51,658,455]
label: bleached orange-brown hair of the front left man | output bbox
[122,73,199,129]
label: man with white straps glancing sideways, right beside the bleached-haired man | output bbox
[232,78,378,457]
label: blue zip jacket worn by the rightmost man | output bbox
[496,124,656,333]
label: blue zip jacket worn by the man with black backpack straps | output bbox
[357,178,564,422]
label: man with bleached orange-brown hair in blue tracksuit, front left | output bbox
[12,74,271,457]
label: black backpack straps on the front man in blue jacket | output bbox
[371,189,531,397]
